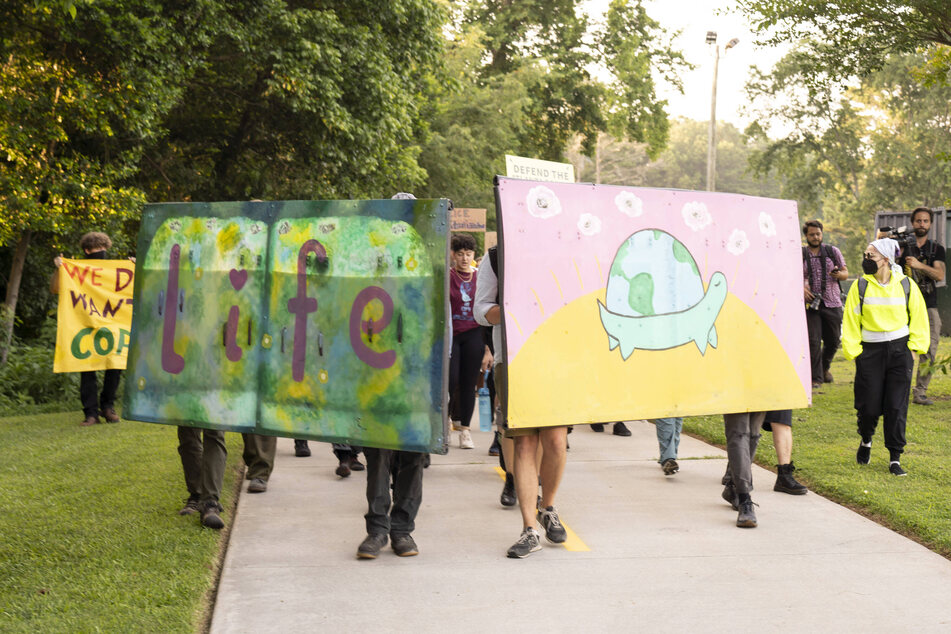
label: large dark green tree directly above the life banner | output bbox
[136,0,445,200]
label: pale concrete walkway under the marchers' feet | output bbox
[212,422,951,634]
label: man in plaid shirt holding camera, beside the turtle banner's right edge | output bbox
[802,220,849,389]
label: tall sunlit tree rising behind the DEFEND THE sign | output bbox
[464,0,687,160]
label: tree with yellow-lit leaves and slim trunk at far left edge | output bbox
[0,0,214,363]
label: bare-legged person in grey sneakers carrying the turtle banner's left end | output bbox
[474,247,568,559]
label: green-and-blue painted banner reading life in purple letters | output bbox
[123,199,448,453]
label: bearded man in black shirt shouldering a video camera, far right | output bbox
[898,207,945,405]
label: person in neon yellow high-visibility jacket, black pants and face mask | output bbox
[842,238,930,476]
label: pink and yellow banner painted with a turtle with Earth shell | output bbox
[496,178,811,427]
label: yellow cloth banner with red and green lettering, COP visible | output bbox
[53,258,135,372]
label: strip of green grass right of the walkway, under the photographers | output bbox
[684,338,951,557]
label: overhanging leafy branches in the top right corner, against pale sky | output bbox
[738,0,951,80]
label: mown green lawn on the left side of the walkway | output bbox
[0,412,241,632]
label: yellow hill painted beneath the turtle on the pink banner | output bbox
[508,289,809,427]
